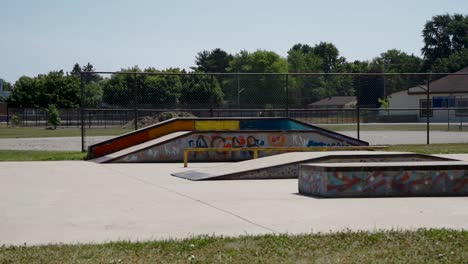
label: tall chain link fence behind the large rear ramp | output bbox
[0,72,468,151]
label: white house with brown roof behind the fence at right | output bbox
[388,67,468,122]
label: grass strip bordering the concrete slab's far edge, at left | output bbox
[0,150,86,161]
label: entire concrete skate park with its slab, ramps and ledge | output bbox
[1,115,468,244]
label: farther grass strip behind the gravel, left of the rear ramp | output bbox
[0,127,132,139]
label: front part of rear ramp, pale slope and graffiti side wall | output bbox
[95,130,370,163]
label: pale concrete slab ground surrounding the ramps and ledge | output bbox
[0,155,468,245]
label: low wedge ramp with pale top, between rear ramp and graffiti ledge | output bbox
[172,151,452,181]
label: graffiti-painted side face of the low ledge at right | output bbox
[299,165,468,197]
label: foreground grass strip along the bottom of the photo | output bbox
[0,229,468,263]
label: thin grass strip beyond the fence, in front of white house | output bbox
[319,124,468,132]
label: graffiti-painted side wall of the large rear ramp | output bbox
[115,131,349,162]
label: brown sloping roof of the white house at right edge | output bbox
[408,67,468,94]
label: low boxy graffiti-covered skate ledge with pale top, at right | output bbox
[299,161,468,198]
